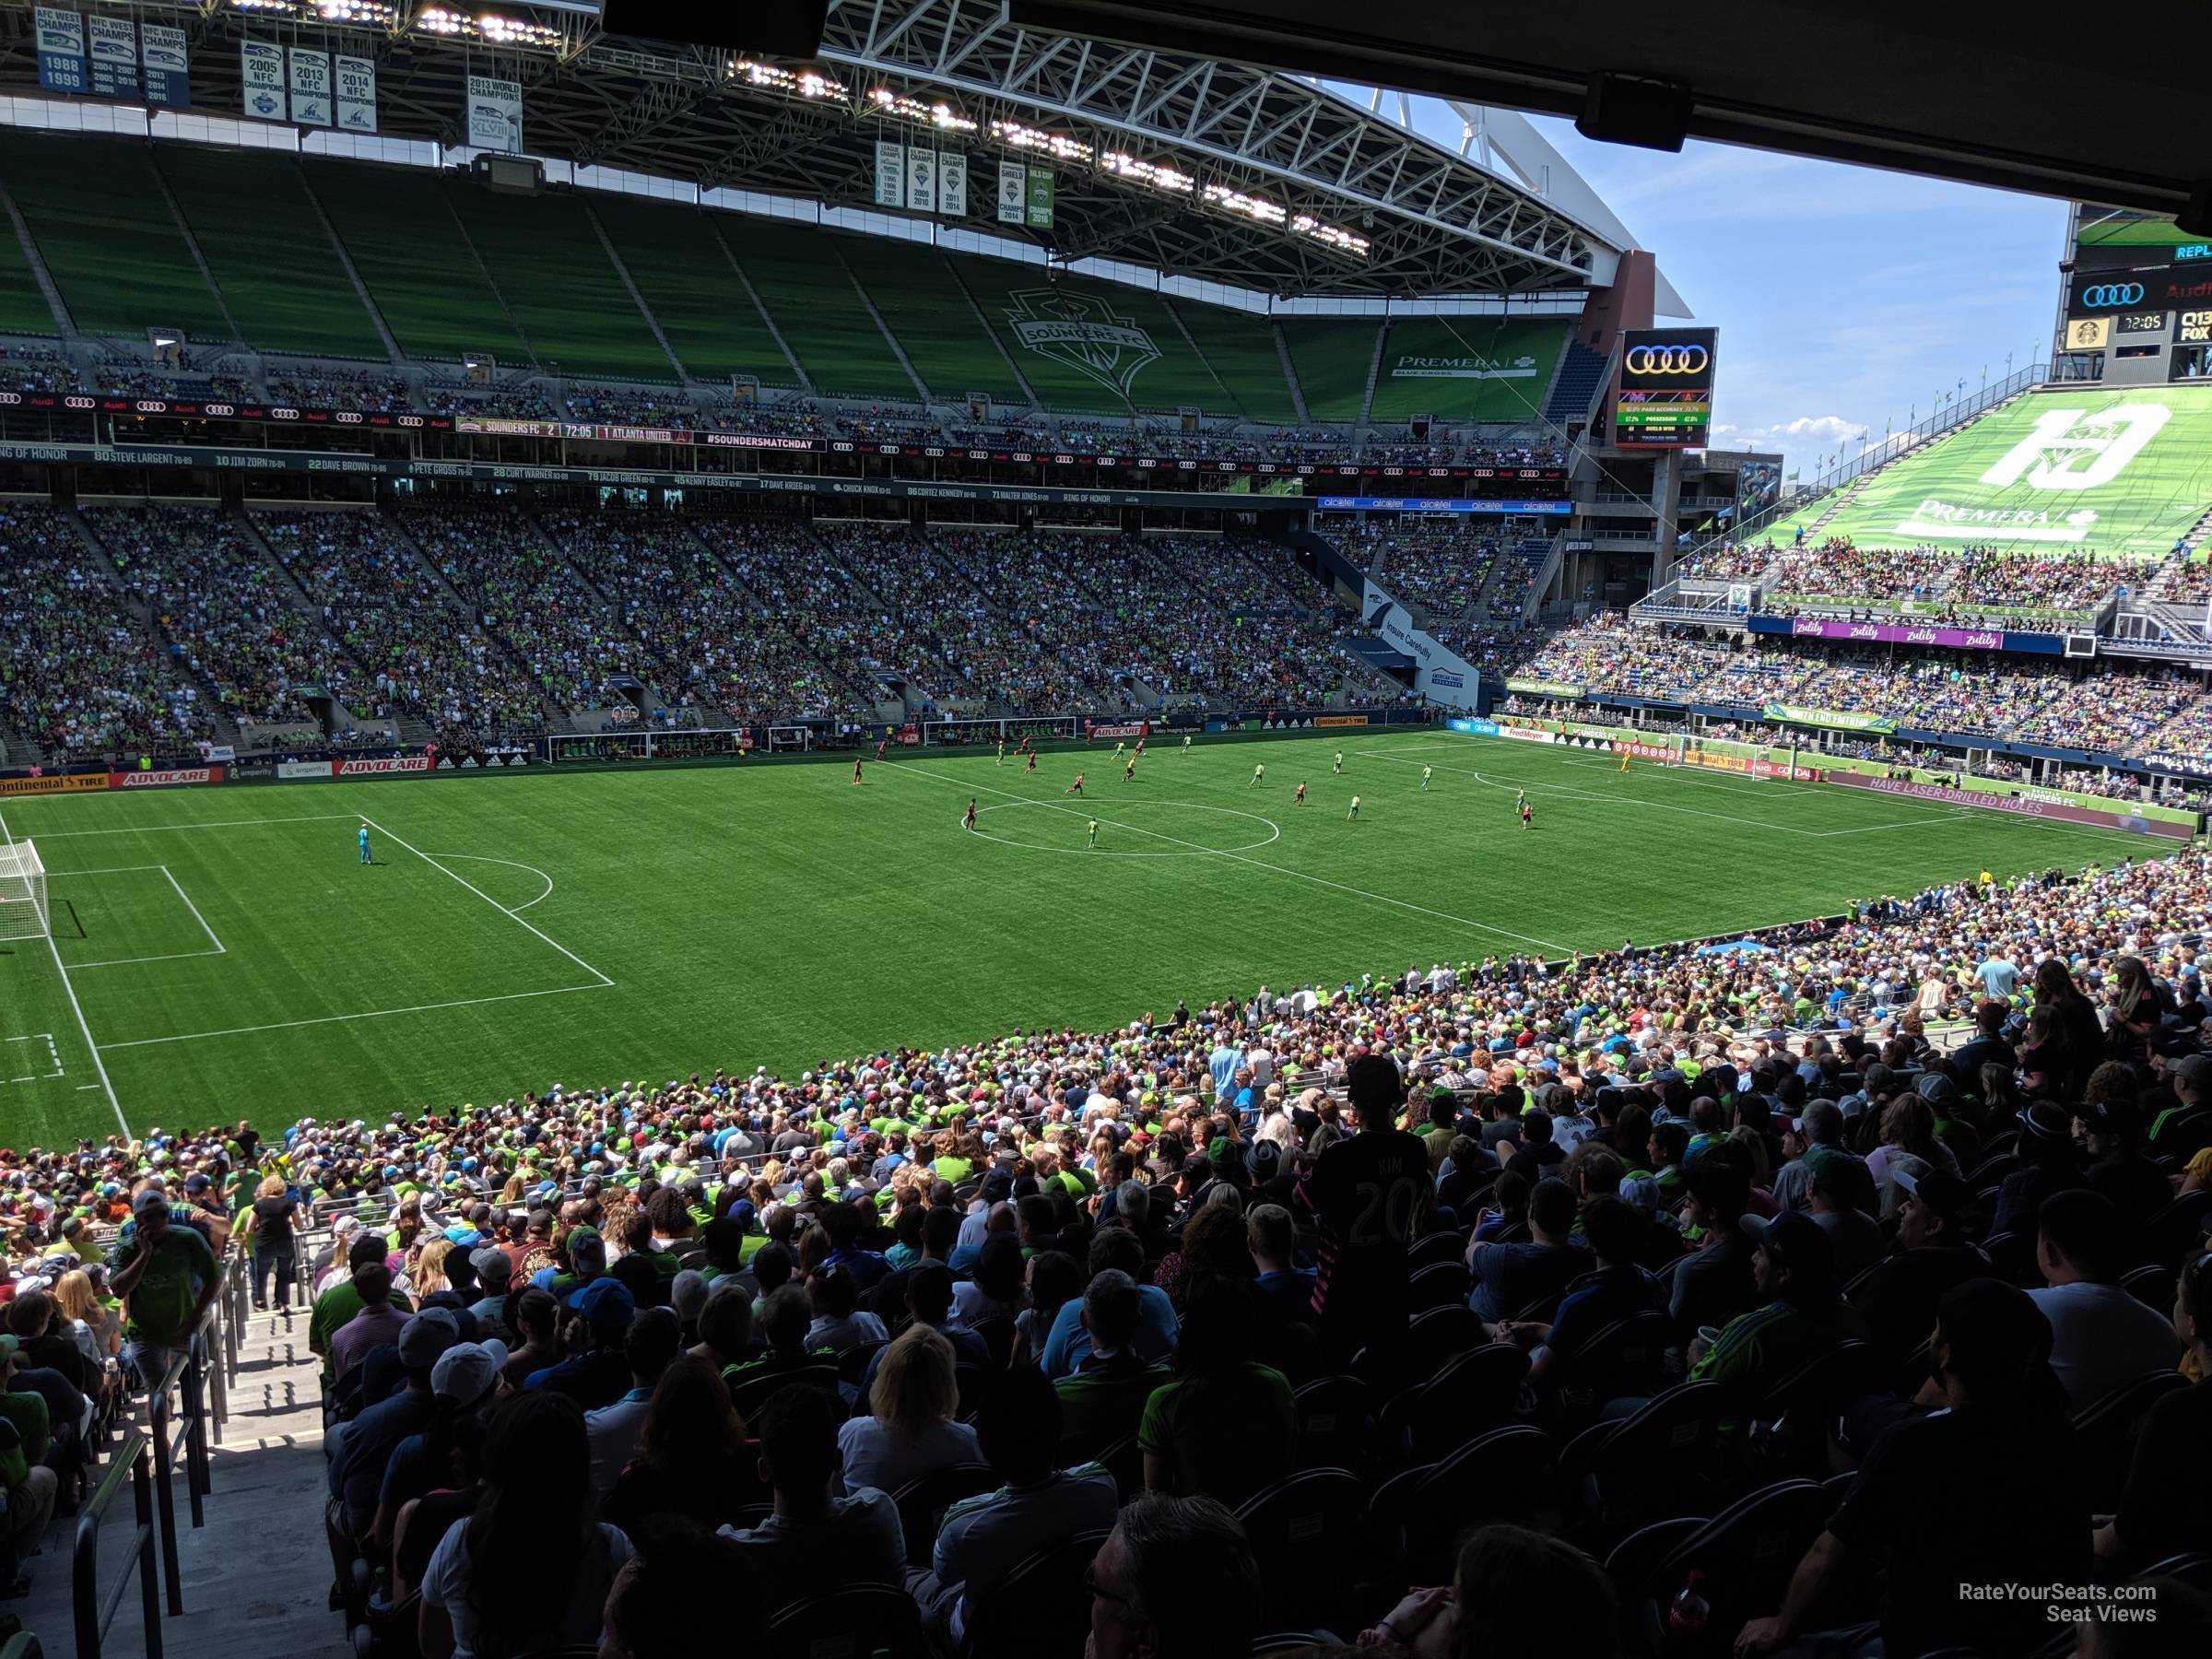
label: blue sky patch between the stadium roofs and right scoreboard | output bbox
[1416,100,2066,471]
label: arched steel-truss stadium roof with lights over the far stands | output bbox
[0,0,1672,300]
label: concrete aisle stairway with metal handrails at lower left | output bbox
[5,1307,352,1659]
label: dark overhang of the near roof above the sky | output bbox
[1008,0,2212,234]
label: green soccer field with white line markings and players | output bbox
[0,730,2159,1148]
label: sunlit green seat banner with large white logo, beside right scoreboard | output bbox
[1825,385,2212,559]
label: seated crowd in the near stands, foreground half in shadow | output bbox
[13,852,2212,1659]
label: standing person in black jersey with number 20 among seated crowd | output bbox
[1299,1055,1436,1359]
